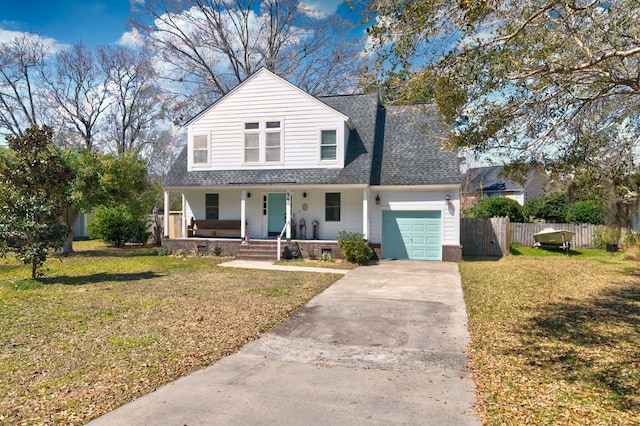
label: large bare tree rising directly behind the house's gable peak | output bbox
[132,0,360,116]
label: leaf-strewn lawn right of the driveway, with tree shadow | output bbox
[460,247,640,425]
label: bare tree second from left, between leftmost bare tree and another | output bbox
[42,42,110,149]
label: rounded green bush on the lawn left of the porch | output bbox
[89,206,151,247]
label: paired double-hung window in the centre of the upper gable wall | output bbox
[244,120,282,163]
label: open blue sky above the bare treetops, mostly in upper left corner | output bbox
[0,0,353,48]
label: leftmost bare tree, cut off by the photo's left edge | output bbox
[0,34,48,137]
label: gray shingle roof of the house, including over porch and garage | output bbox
[163,93,460,187]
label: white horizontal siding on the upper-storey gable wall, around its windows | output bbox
[188,72,348,170]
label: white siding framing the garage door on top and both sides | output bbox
[369,189,460,245]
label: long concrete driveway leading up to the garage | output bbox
[91,261,480,426]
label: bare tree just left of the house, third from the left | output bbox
[98,46,164,153]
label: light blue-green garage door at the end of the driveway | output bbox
[382,211,442,260]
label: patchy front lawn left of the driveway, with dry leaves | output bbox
[0,242,340,425]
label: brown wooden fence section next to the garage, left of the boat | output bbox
[460,217,511,257]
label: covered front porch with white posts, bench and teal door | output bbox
[164,187,375,242]
